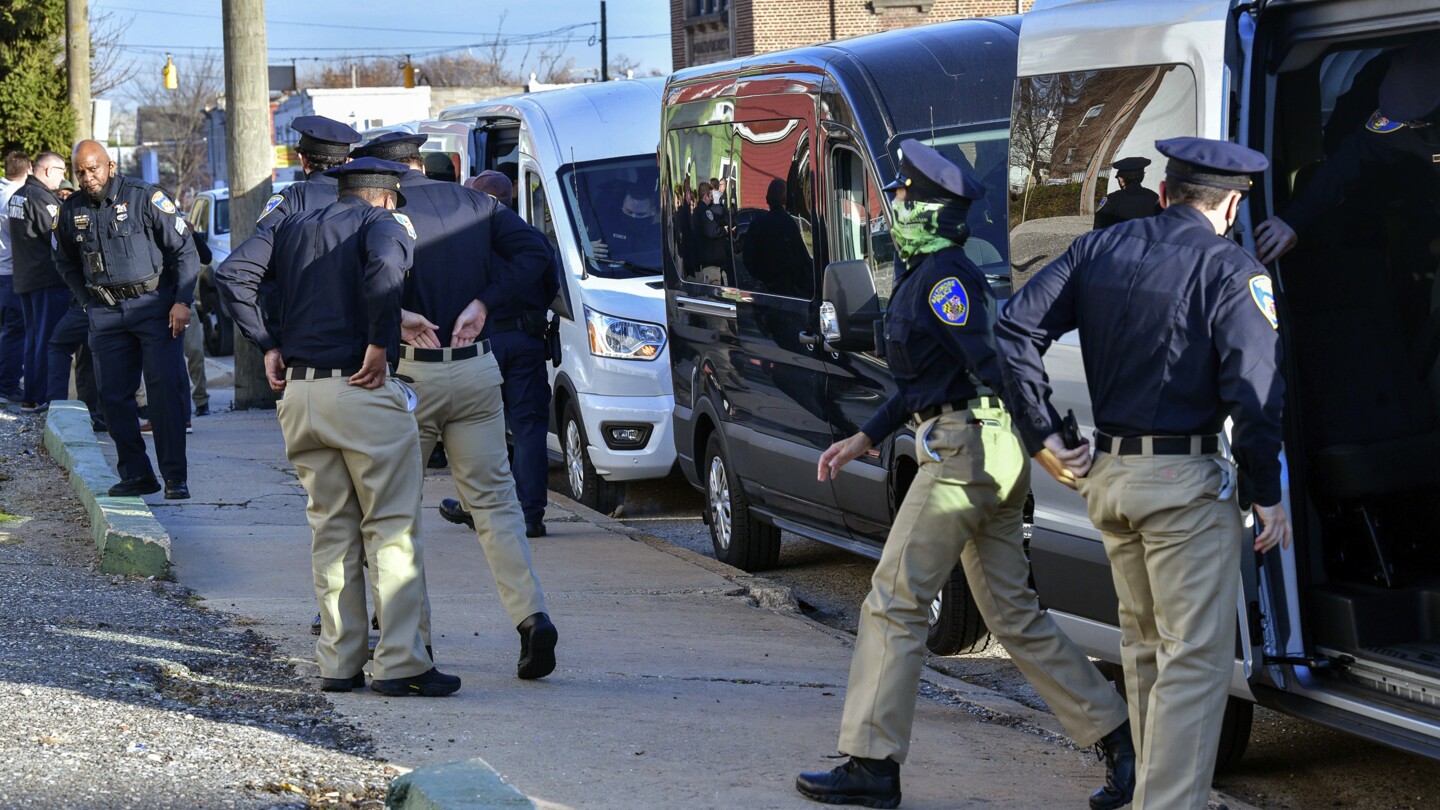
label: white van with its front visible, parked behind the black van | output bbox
[420,79,675,513]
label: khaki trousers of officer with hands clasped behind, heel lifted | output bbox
[397,349,549,631]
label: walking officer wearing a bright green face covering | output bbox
[795,140,1135,809]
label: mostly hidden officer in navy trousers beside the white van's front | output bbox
[441,169,560,538]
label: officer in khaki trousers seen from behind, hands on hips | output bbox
[216,160,459,696]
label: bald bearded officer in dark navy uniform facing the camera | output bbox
[55,141,200,499]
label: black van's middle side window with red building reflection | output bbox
[727,118,815,300]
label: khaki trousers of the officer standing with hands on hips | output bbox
[276,376,433,679]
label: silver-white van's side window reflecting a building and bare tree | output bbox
[1008,65,1198,288]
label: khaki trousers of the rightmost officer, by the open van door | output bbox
[1080,453,1244,810]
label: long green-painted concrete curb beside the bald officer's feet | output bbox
[45,399,170,577]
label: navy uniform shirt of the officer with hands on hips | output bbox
[216,196,415,369]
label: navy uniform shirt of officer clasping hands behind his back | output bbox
[400,169,553,346]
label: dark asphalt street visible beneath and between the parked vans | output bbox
[584,468,1440,810]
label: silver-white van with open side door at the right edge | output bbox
[1009,0,1440,767]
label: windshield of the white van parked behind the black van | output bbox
[559,154,661,278]
